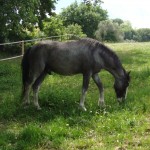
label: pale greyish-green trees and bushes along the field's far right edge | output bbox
[95,18,150,42]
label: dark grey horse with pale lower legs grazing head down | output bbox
[22,38,130,111]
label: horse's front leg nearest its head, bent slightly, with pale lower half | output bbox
[92,73,105,107]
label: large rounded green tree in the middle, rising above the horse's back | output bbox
[60,2,107,37]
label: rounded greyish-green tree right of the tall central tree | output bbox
[95,20,123,42]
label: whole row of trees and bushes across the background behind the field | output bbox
[0,0,150,46]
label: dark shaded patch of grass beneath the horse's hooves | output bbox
[0,86,136,125]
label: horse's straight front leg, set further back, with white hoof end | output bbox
[80,74,91,111]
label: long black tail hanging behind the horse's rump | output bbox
[21,47,31,94]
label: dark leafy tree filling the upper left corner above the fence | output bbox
[0,0,57,43]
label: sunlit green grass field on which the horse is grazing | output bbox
[0,43,150,150]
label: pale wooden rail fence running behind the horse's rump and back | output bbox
[0,34,79,62]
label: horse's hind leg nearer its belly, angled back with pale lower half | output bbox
[32,71,47,110]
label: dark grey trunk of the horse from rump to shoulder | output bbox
[28,40,99,75]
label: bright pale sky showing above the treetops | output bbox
[56,0,150,29]
